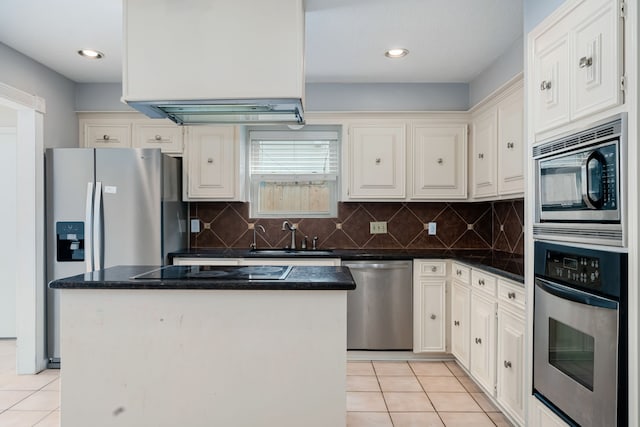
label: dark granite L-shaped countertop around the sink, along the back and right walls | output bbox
[169,249,524,283]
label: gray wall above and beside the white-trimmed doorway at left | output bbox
[0,43,78,147]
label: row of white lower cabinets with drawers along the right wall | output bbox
[450,261,528,426]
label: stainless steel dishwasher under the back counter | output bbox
[342,260,413,350]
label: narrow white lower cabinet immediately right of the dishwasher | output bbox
[413,260,447,353]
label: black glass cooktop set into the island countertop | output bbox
[132,265,293,281]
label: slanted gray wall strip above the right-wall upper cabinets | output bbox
[469,37,524,107]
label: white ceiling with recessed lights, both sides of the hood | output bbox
[0,0,522,83]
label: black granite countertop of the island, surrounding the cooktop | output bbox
[49,265,356,290]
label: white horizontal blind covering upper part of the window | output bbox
[250,131,339,181]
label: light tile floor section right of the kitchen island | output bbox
[347,361,512,427]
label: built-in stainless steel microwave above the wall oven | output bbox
[533,114,626,246]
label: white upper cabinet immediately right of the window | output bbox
[347,120,407,199]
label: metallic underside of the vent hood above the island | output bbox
[128,99,304,125]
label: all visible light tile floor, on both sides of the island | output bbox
[0,339,511,427]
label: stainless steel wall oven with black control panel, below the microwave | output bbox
[533,242,628,427]
